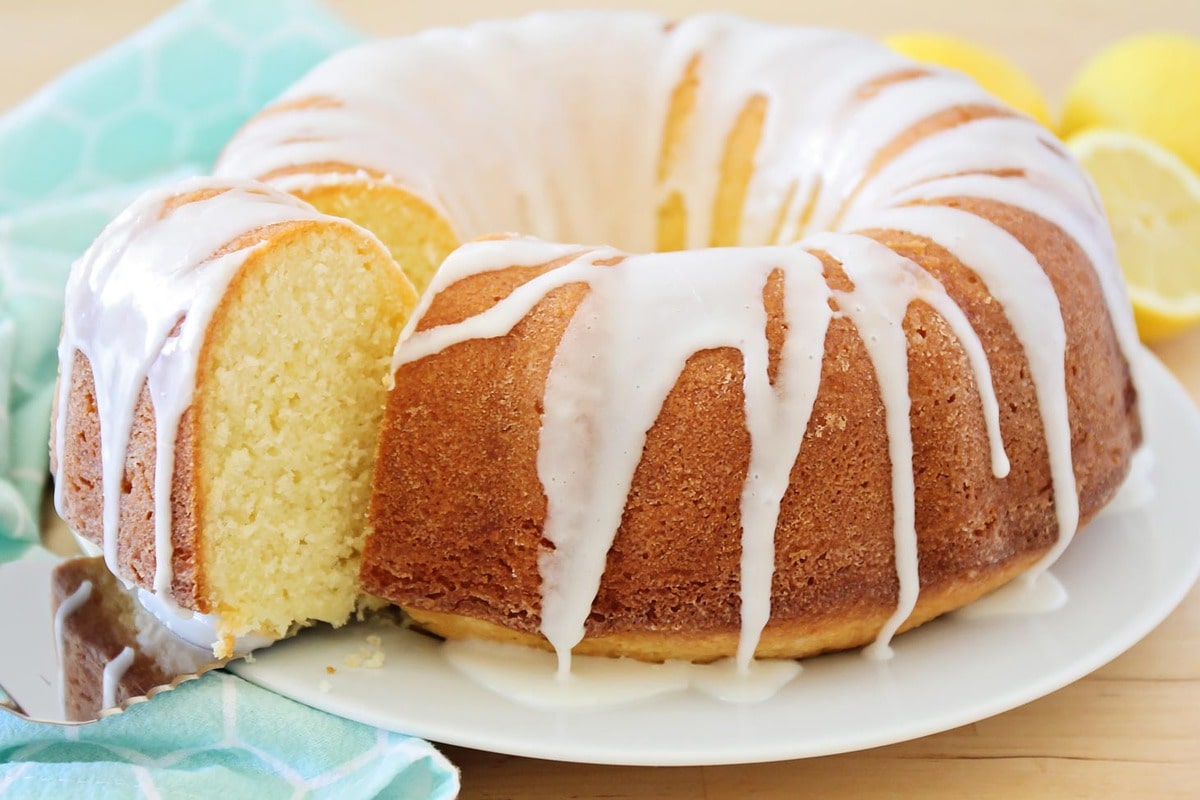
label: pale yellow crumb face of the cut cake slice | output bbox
[196,225,414,636]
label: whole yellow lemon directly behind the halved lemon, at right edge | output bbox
[1062,34,1200,170]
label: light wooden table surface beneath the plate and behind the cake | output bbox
[0,0,1200,800]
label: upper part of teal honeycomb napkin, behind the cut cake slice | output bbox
[0,0,360,559]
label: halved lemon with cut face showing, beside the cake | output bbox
[1067,128,1200,342]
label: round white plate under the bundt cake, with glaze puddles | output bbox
[230,355,1200,765]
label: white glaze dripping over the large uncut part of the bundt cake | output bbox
[70,12,1136,670]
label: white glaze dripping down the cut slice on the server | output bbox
[53,179,344,645]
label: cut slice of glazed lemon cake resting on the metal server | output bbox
[52,179,416,655]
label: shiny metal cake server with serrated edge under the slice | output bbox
[0,558,245,726]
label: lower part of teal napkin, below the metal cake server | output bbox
[0,673,457,800]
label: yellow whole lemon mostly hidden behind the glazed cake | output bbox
[884,32,1050,127]
